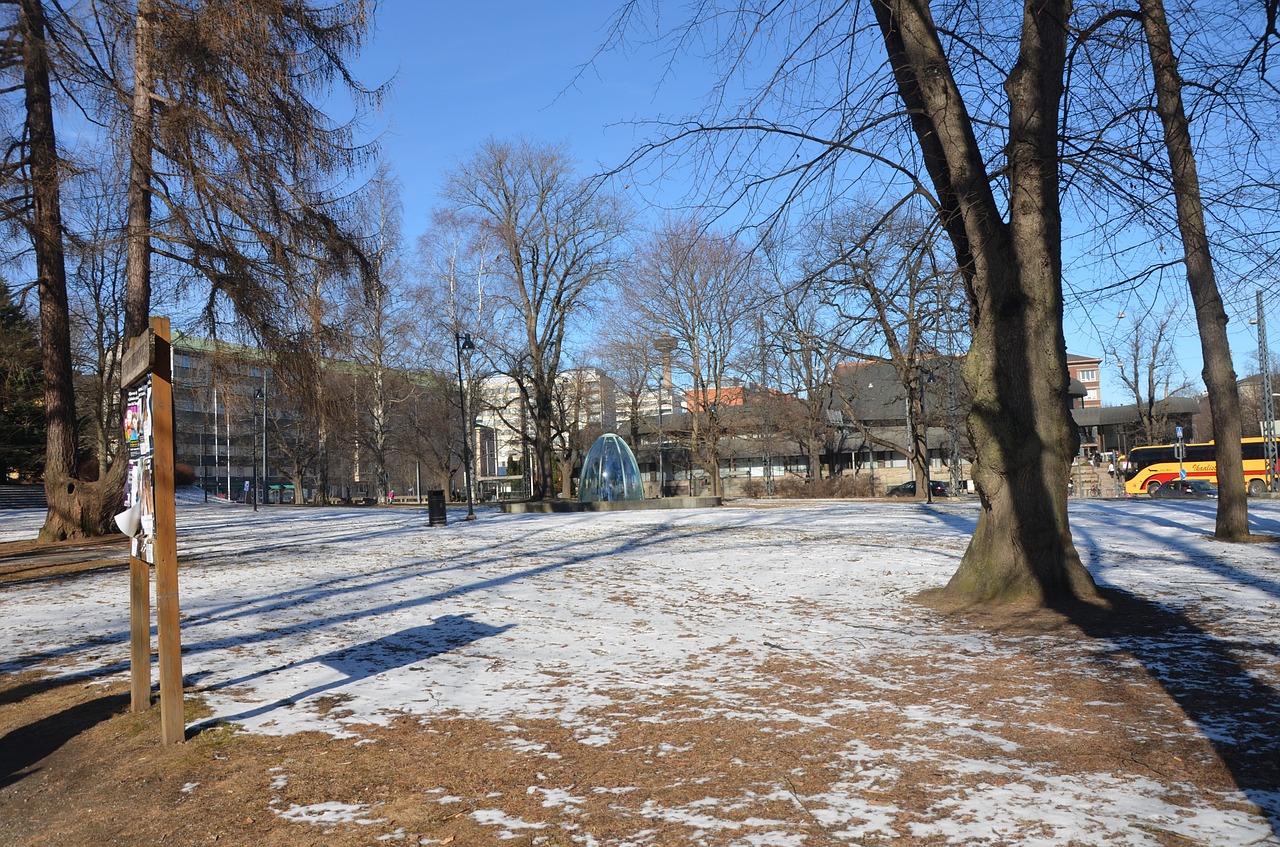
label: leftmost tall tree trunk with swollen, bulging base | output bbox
[18,0,124,541]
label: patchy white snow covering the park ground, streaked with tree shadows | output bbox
[0,500,1280,846]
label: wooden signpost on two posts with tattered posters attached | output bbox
[115,317,186,743]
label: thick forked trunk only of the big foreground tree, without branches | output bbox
[873,0,1097,604]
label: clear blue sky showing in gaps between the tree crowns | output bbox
[357,0,1280,404]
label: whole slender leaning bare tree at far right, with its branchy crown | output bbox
[1062,0,1280,540]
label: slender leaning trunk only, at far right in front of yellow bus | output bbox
[1139,0,1249,541]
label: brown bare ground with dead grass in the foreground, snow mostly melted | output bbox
[0,545,1280,847]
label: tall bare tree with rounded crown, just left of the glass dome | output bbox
[445,141,626,498]
